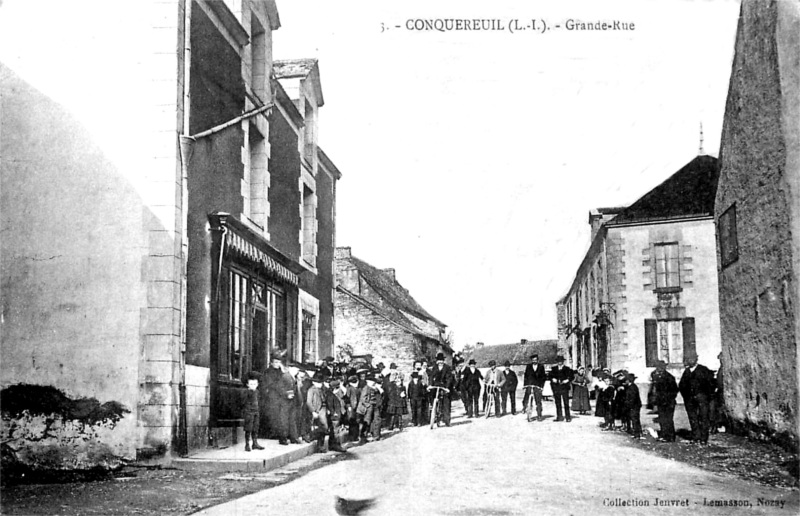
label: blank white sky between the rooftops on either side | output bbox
[274,0,739,347]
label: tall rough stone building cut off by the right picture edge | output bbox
[715,1,800,450]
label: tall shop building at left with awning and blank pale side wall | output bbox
[0,0,340,468]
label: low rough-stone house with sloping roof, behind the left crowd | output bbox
[334,247,453,372]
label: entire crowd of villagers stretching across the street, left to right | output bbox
[243,350,722,451]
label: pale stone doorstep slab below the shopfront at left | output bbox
[172,440,317,472]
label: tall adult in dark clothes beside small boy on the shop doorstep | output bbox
[259,350,300,444]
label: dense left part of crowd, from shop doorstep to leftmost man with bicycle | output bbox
[243,350,457,452]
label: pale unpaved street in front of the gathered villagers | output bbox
[194,403,800,516]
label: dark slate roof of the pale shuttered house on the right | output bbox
[606,156,719,226]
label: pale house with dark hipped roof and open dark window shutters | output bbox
[556,156,720,393]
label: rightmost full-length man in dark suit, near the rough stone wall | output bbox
[678,352,716,444]
